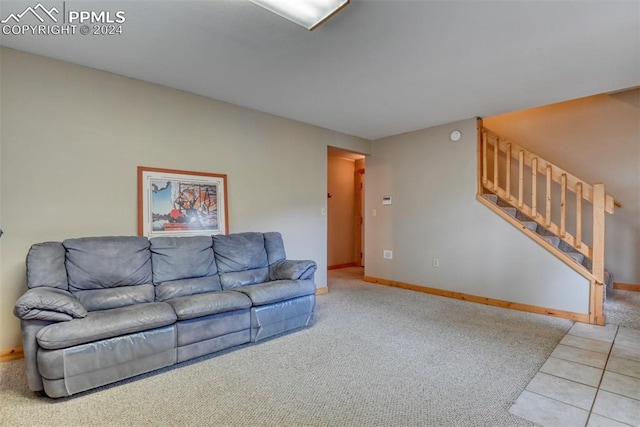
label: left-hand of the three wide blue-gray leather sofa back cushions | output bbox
[62,236,154,311]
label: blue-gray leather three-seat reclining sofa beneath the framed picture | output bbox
[14,233,317,398]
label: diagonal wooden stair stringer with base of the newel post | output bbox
[476,194,605,325]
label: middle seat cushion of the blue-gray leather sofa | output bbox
[167,291,251,320]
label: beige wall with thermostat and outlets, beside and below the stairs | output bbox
[365,119,589,314]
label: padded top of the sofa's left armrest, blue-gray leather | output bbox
[13,287,87,322]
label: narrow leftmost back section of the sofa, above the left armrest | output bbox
[27,242,69,290]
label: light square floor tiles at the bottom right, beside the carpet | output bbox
[509,323,640,427]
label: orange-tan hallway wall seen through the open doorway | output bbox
[327,156,357,266]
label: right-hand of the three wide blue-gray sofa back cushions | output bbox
[213,233,269,289]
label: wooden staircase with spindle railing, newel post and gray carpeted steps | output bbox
[477,120,620,325]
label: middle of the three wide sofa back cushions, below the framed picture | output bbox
[149,236,222,301]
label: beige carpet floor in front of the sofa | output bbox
[0,268,573,426]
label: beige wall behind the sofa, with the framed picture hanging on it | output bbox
[0,48,370,349]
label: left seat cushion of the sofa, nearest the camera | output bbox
[36,302,177,350]
